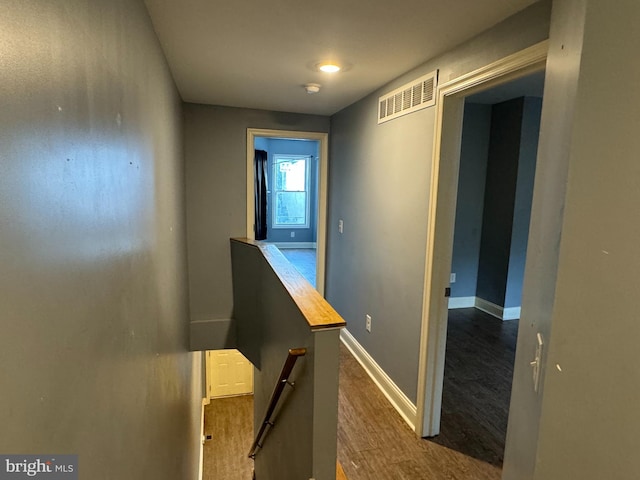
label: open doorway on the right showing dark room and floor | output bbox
[431,71,544,467]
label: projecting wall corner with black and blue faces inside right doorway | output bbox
[476,97,541,308]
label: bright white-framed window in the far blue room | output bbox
[272,155,311,228]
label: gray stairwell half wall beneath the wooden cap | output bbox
[231,241,340,480]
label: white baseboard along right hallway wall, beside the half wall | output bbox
[340,328,417,431]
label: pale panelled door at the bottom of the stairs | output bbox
[207,350,253,398]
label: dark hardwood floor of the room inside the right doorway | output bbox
[431,308,518,466]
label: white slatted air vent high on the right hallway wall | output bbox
[378,70,438,124]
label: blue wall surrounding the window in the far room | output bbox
[256,138,320,243]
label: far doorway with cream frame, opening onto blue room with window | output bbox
[247,129,328,295]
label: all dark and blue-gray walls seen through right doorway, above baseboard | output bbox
[451,97,542,308]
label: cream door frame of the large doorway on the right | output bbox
[415,41,548,437]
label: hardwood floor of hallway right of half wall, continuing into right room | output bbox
[338,309,517,480]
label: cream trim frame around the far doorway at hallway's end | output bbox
[242,128,329,297]
